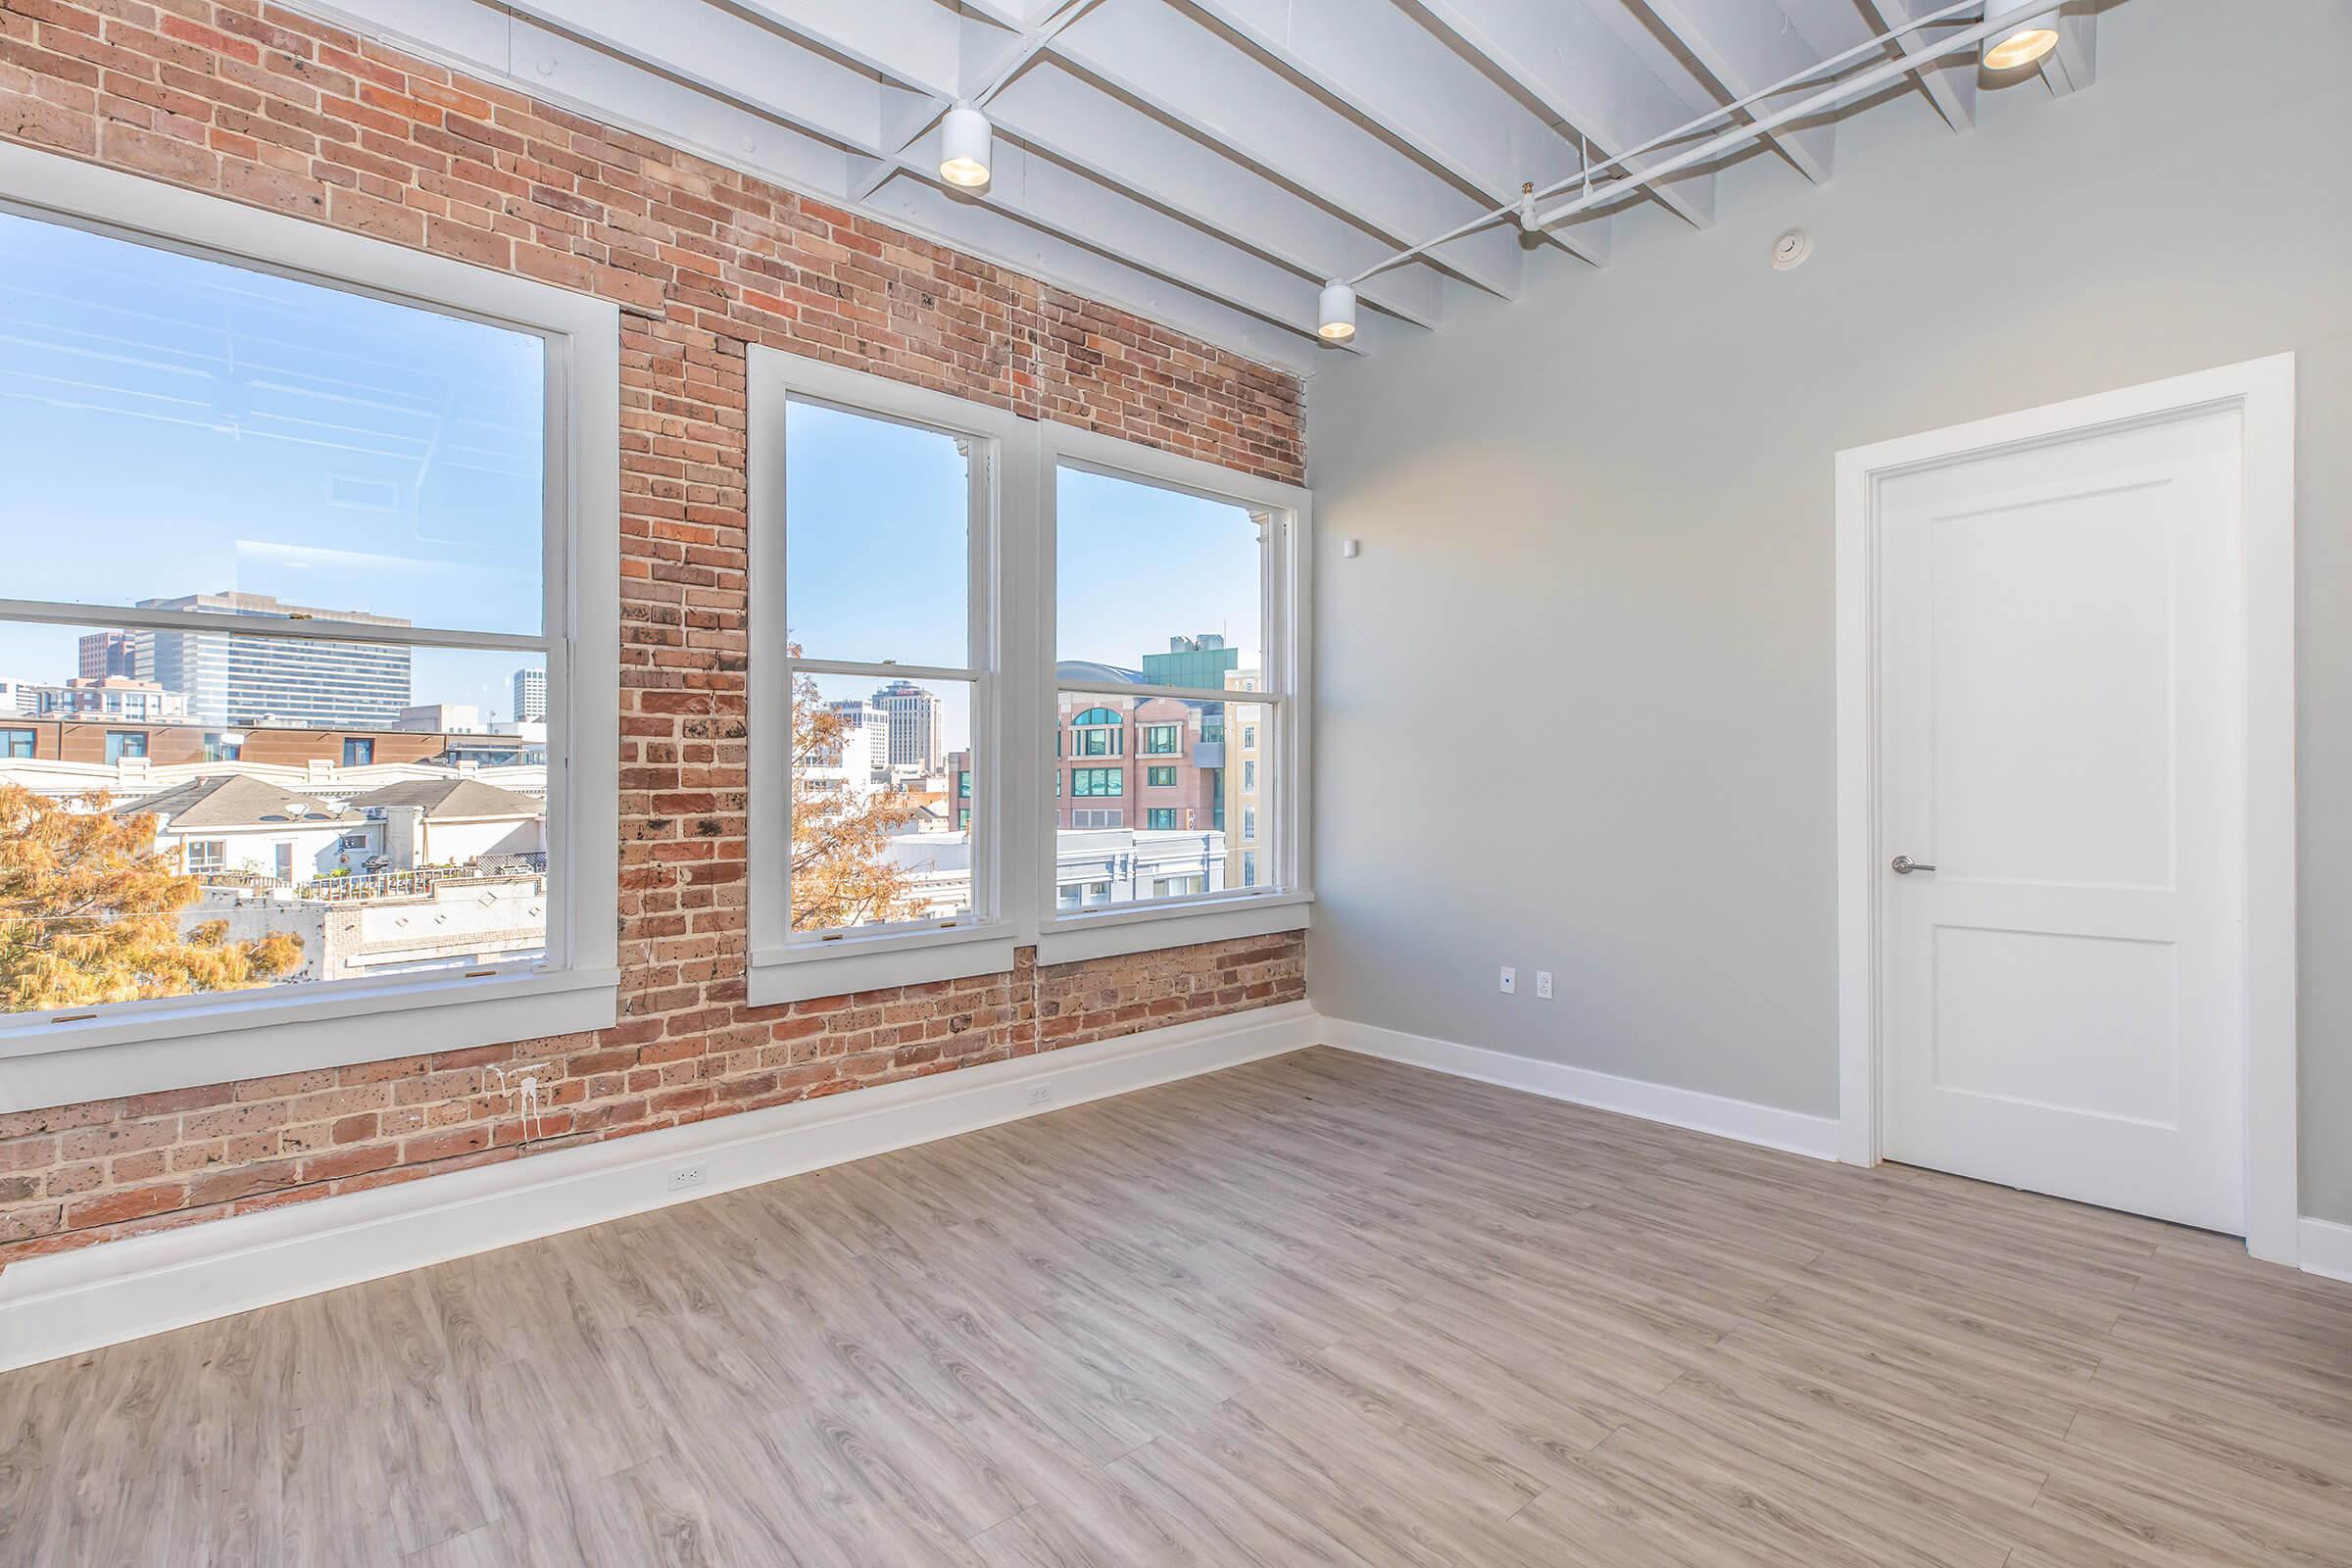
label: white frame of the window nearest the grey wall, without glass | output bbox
[1033,420,1315,964]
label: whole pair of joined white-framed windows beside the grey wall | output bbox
[748,357,1310,1004]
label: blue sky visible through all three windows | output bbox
[0,214,1258,745]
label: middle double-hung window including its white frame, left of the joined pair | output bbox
[751,348,1023,1002]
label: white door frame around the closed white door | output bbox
[1837,353,2298,1265]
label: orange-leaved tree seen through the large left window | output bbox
[0,780,301,1013]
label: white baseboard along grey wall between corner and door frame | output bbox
[1322,1018,1837,1159]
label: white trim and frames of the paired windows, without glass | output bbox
[748,368,1312,1006]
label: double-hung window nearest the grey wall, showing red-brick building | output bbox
[1040,425,1310,959]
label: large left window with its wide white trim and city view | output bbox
[0,148,618,1104]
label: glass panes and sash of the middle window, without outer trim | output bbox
[783,395,993,941]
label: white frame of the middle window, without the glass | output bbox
[746,343,1035,1006]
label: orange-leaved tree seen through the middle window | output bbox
[793,647,922,931]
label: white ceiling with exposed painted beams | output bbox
[301,0,2098,371]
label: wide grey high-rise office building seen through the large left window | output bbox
[139,592,410,729]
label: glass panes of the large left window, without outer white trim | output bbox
[0,212,569,1029]
